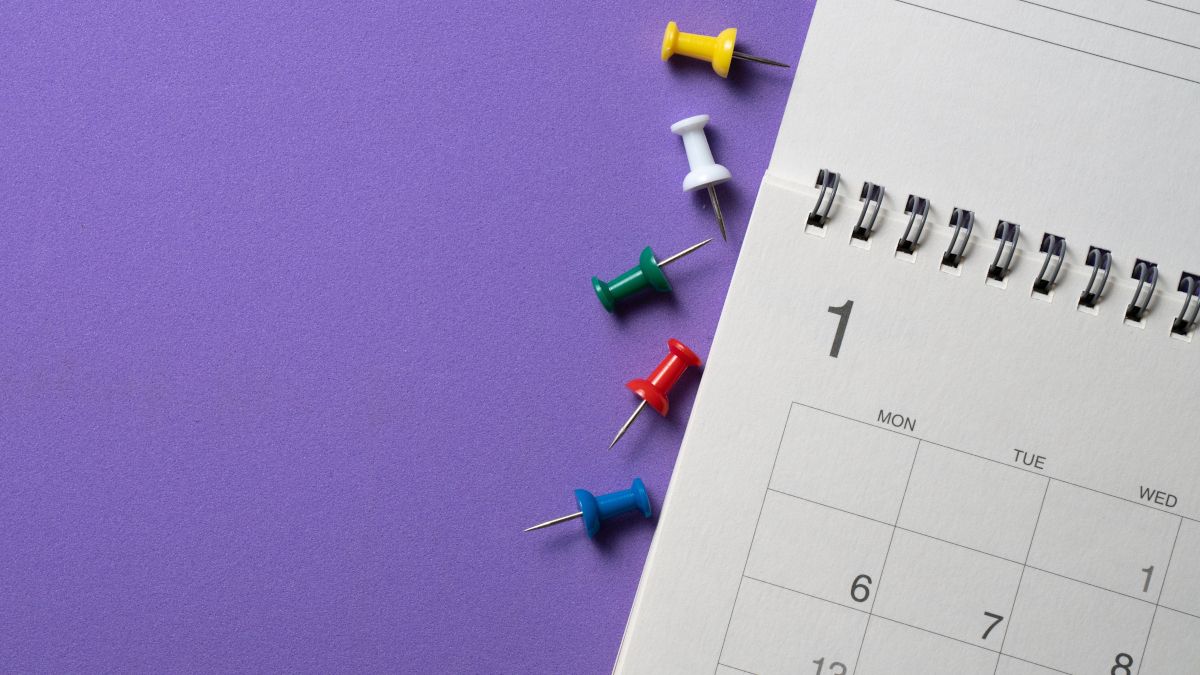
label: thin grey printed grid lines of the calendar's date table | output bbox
[715,401,1200,673]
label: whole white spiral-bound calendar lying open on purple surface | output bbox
[614,0,1200,675]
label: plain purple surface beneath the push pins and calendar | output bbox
[0,0,811,673]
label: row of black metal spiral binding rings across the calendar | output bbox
[805,169,1200,339]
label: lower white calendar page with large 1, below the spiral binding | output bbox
[617,177,1200,675]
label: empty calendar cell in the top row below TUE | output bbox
[900,443,1049,562]
